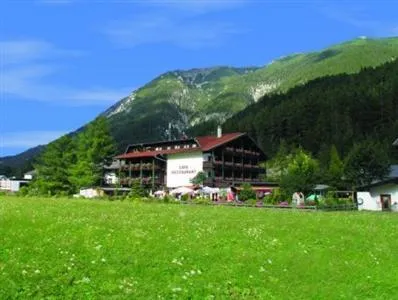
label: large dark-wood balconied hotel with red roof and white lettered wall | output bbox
[112,128,274,189]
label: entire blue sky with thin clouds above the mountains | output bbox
[0,0,398,157]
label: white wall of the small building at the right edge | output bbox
[357,183,398,211]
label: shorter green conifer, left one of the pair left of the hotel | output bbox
[29,135,74,195]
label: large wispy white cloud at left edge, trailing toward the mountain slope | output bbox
[0,40,130,106]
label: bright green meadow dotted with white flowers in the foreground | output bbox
[0,197,398,299]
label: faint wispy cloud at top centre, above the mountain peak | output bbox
[104,0,246,49]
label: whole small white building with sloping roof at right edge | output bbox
[357,165,398,211]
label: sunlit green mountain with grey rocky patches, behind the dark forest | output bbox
[0,38,398,175]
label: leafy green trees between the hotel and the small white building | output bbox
[266,140,390,197]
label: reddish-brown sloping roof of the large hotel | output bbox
[115,132,246,159]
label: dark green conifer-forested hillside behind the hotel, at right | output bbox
[224,61,398,162]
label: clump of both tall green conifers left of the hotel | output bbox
[25,116,116,195]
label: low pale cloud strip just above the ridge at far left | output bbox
[0,131,67,148]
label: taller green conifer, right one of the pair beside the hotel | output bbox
[69,117,115,189]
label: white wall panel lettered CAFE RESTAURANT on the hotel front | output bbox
[166,151,203,188]
